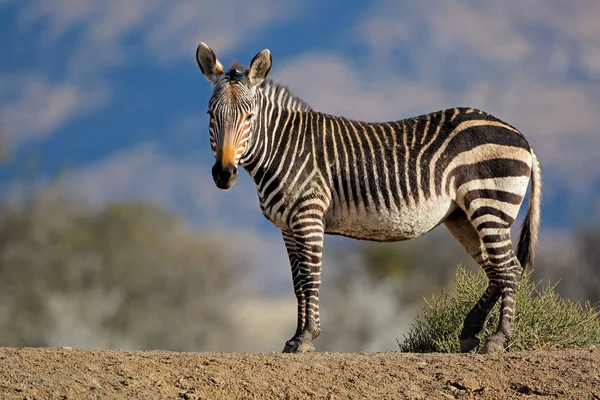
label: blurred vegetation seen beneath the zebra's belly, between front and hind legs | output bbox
[317,233,478,351]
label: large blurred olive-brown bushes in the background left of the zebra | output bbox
[0,185,239,350]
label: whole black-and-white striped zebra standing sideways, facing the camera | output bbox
[196,43,541,353]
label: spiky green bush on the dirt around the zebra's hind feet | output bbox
[398,265,600,353]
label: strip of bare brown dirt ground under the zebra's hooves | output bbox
[0,347,600,400]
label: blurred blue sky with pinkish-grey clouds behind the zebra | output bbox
[0,0,600,238]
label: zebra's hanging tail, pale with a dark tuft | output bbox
[517,150,542,270]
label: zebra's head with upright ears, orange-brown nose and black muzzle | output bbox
[196,42,272,189]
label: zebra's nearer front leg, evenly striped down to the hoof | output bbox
[283,218,324,353]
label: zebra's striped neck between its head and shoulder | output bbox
[241,80,312,178]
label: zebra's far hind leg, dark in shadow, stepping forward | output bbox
[444,209,500,353]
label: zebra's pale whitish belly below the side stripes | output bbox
[325,199,456,242]
